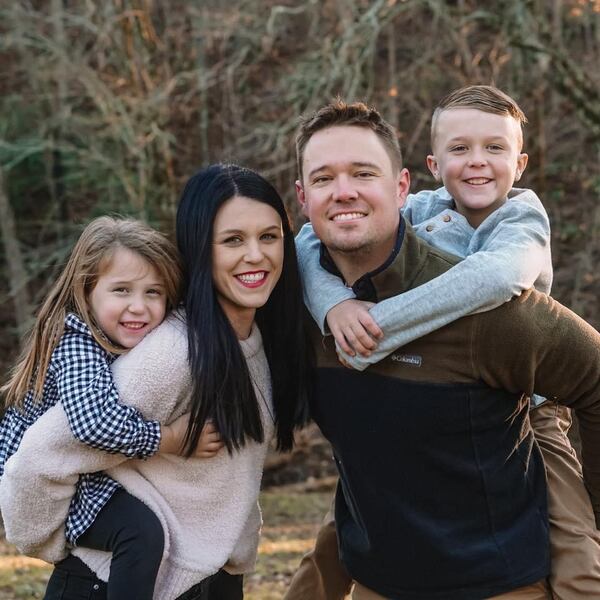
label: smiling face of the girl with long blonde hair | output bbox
[88,248,167,348]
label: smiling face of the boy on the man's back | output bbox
[427,108,527,227]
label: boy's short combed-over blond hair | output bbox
[431,85,527,148]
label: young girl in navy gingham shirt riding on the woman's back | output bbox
[0,217,214,598]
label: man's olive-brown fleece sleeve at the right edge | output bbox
[472,291,600,526]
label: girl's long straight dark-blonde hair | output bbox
[1,217,181,406]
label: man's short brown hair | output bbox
[296,98,402,180]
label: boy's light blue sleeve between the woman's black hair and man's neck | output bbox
[296,223,355,334]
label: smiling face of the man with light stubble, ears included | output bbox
[296,125,410,264]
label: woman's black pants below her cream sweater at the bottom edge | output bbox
[44,556,244,600]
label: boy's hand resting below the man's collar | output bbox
[327,300,383,356]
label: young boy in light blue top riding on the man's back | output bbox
[286,86,600,600]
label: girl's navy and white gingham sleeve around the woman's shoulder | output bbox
[56,336,160,458]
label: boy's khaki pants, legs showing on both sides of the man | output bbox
[284,402,600,600]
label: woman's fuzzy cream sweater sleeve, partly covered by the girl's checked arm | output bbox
[0,317,190,562]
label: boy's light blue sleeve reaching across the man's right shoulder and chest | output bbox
[344,190,550,371]
